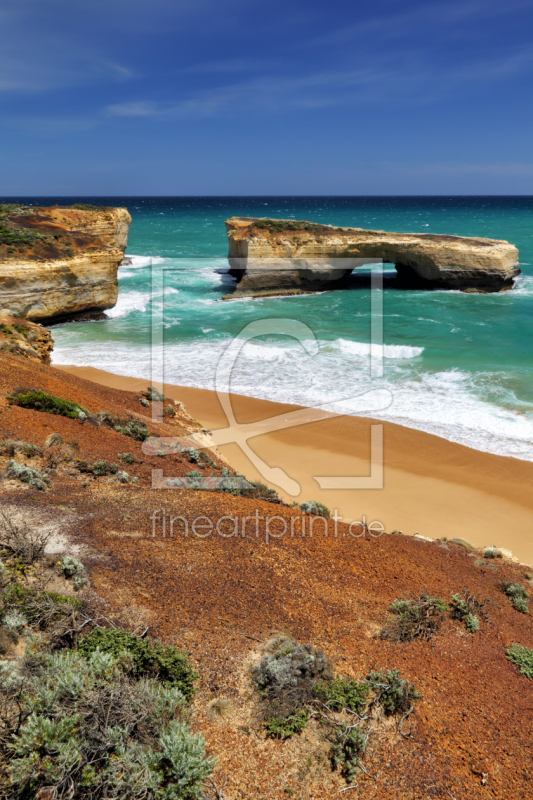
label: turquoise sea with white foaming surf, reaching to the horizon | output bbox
[6,197,533,461]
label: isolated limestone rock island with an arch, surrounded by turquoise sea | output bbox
[225,217,520,299]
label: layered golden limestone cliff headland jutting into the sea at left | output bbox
[0,206,131,320]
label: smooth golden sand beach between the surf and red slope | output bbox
[58,367,533,564]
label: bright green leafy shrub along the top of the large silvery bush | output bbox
[79,628,198,700]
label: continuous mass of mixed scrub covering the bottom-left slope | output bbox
[0,513,210,800]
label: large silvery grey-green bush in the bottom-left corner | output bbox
[4,650,215,800]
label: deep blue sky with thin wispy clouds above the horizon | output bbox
[0,0,533,196]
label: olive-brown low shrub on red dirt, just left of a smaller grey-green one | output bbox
[380,592,447,642]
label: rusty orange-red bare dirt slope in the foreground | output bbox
[0,353,533,800]
